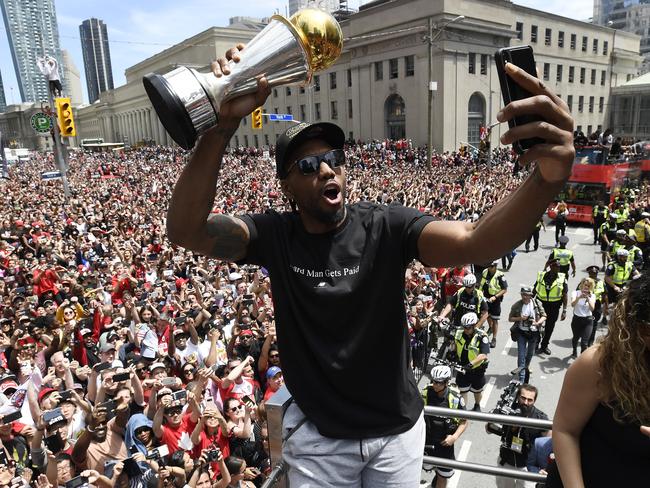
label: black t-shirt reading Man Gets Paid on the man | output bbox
[238,202,433,439]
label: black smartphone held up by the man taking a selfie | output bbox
[494,46,545,154]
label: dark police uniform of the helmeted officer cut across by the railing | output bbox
[422,385,465,478]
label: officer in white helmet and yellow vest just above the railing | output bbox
[454,312,490,412]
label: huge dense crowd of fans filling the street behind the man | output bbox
[0,136,647,488]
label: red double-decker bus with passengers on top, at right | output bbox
[547,146,640,223]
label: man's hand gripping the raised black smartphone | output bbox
[497,63,575,183]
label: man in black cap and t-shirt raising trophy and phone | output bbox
[152,9,574,488]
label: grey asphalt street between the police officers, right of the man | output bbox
[422,219,604,488]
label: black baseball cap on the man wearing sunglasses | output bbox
[275,122,345,179]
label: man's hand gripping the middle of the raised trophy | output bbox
[211,43,271,126]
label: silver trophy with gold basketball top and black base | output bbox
[143,8,343,149]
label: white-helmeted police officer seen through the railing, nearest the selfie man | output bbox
[422,364,469,488]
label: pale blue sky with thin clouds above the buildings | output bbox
[0,0,593,104]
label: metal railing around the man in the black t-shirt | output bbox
[262,386,553,488]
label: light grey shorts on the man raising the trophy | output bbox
[282,402,425,488]
